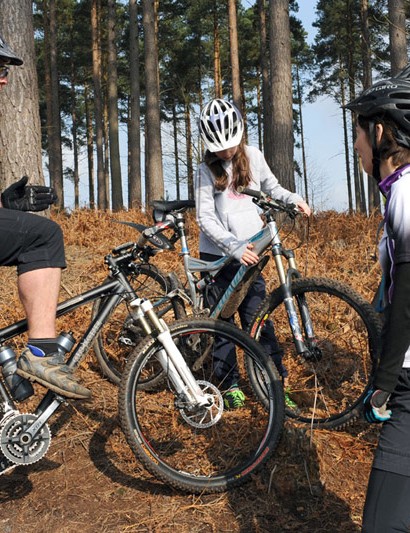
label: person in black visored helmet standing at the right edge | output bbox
[347,65,410,533]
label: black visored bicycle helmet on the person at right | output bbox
[346,64,410,148]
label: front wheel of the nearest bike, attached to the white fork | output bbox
[119,318,284,493]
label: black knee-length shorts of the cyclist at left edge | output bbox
[0,208,66,274]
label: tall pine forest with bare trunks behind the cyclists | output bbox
[0,0,410,213]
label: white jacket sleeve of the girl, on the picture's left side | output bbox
[195,165,247,261]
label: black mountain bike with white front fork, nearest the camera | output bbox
[0,235,284,492]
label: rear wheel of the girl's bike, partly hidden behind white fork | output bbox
[92,264,185,386]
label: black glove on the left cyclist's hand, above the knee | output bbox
[1,176,57,211]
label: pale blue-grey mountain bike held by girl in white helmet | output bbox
[107,190,381,429]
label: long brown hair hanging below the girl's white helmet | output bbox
[204,139,252,191]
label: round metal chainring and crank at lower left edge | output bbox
[0,414,51,465]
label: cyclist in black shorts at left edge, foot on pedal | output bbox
[0,36,91,398]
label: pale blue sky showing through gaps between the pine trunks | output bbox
[64,0,348,211]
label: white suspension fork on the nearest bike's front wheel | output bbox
[130,298,209,406]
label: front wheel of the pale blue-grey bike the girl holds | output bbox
[248,278,381,429]
